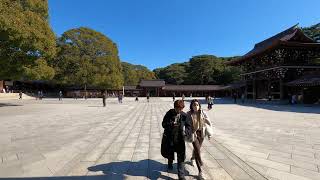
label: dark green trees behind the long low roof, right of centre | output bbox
[154,55,240,85]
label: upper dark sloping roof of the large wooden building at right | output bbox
[227,24,320,65]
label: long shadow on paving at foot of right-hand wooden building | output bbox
[205,98,320,114]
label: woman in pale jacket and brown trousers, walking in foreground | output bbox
[187,99,212,179]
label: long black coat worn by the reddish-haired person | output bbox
[161,109,192,159]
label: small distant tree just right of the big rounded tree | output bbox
[121,62,155,86]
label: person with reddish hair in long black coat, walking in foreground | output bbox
[161,100,192,180]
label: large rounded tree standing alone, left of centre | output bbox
[54,27,123,89]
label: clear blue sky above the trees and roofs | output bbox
[49,0,320,70]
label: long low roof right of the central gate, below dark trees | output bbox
[163,85,224,91]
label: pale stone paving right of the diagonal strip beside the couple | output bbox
[209,100,320,180]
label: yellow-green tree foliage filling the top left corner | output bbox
[0,0,56,79]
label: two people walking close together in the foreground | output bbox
[161,99,212,180]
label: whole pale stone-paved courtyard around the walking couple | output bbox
[0,98,320,180]
